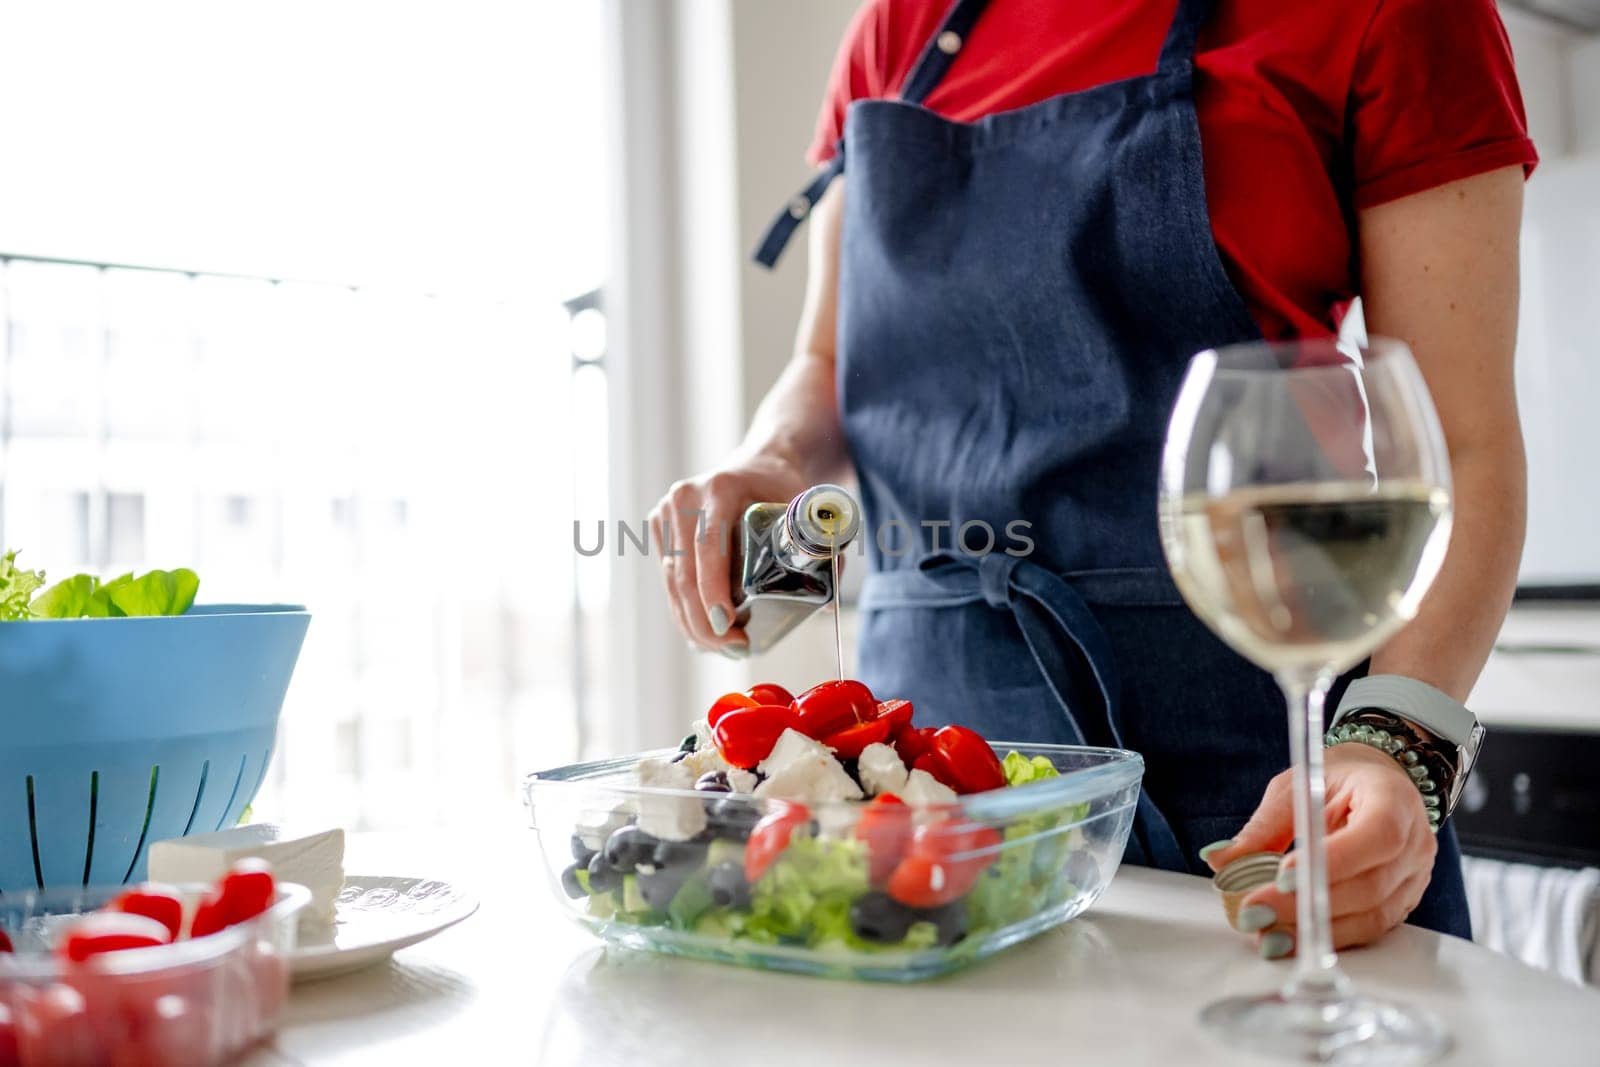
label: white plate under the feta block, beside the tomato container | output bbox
[290,875,478,979]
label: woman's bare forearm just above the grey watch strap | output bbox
[1371,435,1526,701]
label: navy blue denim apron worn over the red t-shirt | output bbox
[757,0,1469,936]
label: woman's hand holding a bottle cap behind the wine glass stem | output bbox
[1205,742,1438,960]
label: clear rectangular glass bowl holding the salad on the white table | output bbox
[523,744,1144,982]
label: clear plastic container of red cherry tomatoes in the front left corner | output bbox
[0,885,310,1067]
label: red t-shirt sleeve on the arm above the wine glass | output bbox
[1349,0,1539,208]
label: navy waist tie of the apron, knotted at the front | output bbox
[883,552,1189,870]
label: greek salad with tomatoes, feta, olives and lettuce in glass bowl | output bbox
[562,680,1088,950]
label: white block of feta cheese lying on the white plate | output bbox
[150,822,344,921]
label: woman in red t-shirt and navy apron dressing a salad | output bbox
[653,0,1536,957]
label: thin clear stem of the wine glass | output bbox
[1278,673,1346,998]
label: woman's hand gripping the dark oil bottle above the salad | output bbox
[650,454,810,659]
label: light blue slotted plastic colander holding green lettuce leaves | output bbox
[0,605,310,893]
